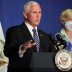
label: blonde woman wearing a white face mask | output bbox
[56,9,72,51]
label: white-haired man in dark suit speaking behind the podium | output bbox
[4,1,54,72]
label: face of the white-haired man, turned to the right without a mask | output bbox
[23,5,41,27]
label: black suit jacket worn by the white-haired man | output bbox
[4,23,54,71]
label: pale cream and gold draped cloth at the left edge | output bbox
[0,22,9,72]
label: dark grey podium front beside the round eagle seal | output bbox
[30,52,59,72]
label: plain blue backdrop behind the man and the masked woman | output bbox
[0,0,72,35]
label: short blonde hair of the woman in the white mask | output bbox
[60,9,72,23]
